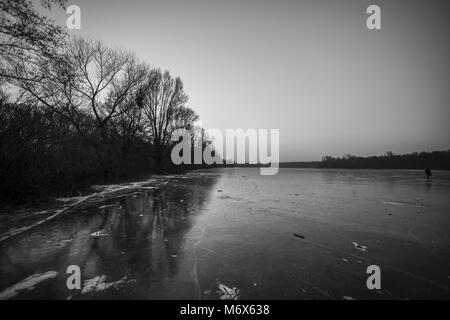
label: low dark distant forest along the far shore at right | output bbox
[280,150,450,170]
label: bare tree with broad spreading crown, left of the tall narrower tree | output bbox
[17,38,148,176]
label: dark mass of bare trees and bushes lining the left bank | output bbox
[0,0,207,200]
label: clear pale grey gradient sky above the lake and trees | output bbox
[37,0,450,161]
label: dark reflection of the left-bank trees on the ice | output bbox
[0,175,216,299]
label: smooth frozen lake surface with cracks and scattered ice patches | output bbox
[0,168,450,299]
